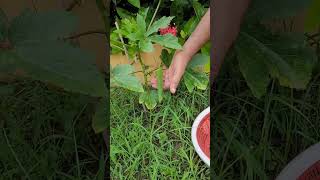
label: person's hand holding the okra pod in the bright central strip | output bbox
[151,51,191,94]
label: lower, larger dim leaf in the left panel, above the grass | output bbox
[16,41,107,97]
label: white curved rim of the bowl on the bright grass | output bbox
[191,106,210,167]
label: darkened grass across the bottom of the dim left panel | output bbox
[0,81,104,180]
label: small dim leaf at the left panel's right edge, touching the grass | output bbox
[92,98,109,133]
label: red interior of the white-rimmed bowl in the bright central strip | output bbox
[197,113,210,159]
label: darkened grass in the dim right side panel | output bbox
[211,57,320,180]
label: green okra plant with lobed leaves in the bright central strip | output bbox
[110,0,209,109]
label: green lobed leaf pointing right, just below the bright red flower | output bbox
[150,34,182,49]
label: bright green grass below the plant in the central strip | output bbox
[110,89,210,180]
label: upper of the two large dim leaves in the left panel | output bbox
[9,11,77,44]
